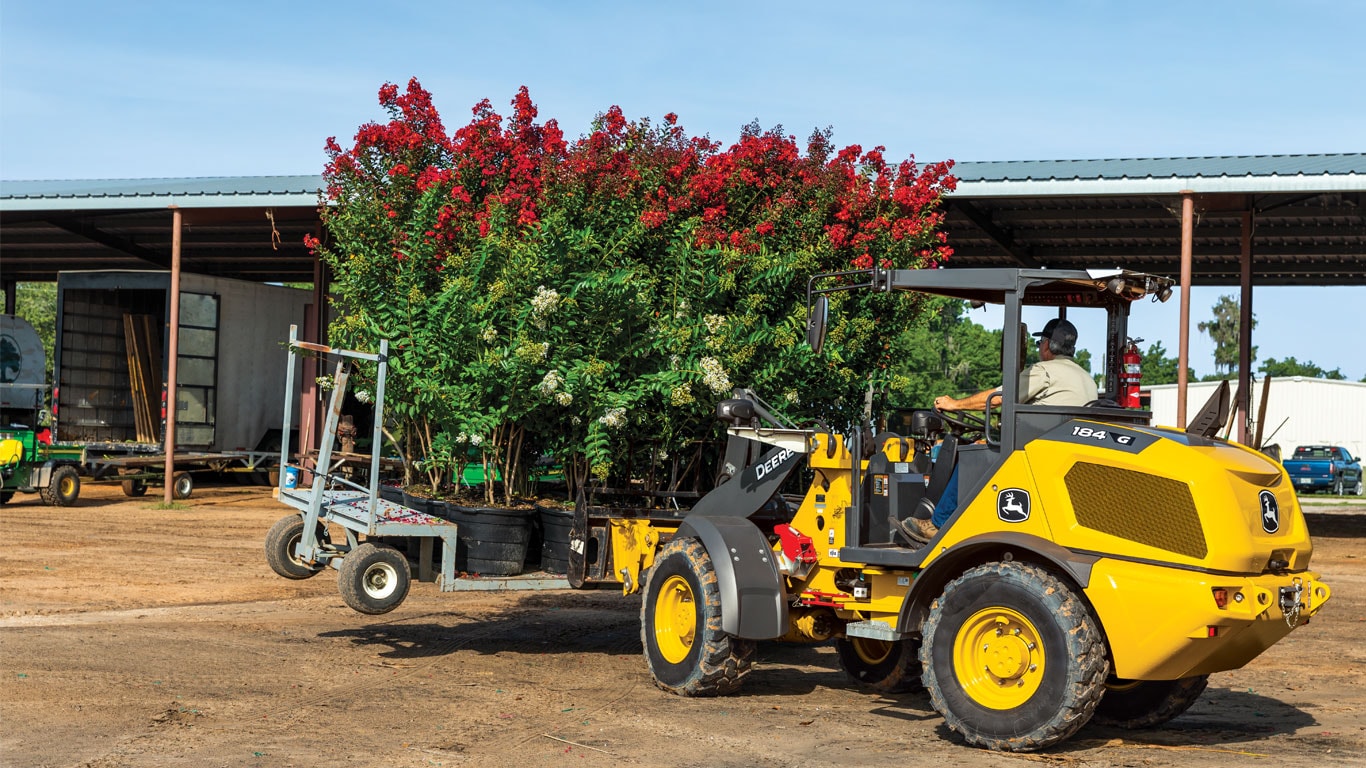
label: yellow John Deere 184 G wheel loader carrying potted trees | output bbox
[592,269,1329,752]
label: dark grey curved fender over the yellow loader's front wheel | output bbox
[673,513,788,640]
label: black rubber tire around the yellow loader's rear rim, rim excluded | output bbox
[921,562,1109,752]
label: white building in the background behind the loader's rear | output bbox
[1147,376,1366,456]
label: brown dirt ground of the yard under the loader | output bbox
[0,485,1366,768]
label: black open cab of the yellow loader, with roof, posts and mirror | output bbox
[807,269,1172,564]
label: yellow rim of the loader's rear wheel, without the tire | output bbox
[953,608,1044,709]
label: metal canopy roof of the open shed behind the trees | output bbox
[0,153,1366,286]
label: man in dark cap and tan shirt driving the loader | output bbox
[900,317,1096,544]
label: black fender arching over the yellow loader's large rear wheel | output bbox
[896,532,1101,633]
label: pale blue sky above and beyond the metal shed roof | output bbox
[0,0,1366,380]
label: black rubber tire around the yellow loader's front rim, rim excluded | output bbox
[641,537,755,697]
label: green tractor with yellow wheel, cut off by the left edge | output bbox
[0,314,81,507]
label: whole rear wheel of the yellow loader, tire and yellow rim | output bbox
[921,562,1109,752]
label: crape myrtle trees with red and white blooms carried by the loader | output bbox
[309,79,955,503]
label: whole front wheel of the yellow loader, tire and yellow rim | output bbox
[641,537,754,696]
